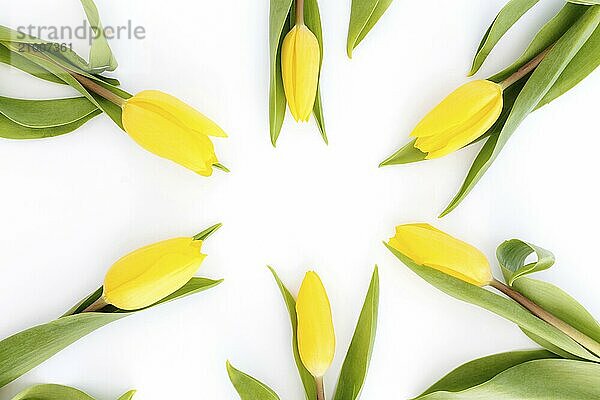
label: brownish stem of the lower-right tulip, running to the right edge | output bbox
[490,279,600,356]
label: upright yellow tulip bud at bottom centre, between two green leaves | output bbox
[296,272,335,378]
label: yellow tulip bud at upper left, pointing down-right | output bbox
[122,90,227,176]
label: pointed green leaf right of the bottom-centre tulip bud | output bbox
[333,267,379,400]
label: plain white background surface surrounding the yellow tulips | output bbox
[0,0,600,400]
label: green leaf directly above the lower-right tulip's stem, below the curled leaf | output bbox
[513,278,600,342]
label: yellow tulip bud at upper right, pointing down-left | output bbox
[411,80,503,159]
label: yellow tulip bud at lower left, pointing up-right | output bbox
[103,238,206,310]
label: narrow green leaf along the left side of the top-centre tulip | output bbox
[269,0,293,146]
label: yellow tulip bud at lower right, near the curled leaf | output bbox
[389,224,493,286]
